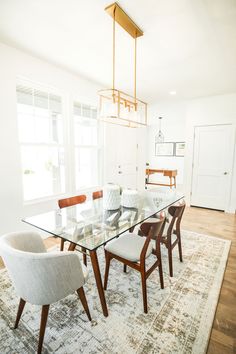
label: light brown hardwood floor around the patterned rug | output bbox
[0,208,236,354]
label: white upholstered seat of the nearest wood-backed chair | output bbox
[105,232,152,262]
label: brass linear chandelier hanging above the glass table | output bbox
[99,2,147,128]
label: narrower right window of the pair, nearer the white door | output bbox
[74,102,99,190]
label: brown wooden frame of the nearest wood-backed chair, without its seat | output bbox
[104,218,165,313]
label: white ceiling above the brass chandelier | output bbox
[0,0,236,103]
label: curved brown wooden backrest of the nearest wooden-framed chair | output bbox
[139,217,166,262]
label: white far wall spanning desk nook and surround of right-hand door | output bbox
[147,93,236,213]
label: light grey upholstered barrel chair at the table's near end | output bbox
[0,232,91,354]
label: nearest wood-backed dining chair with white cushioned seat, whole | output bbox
[104,218,165,313]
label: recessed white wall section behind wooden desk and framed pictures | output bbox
[147,102,186,188]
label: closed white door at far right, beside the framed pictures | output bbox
[191,125,234,210]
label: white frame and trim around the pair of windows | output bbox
[16,77,104,207]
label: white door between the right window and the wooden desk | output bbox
[104,125,137,188]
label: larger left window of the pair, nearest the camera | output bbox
[16,85,65,201]
